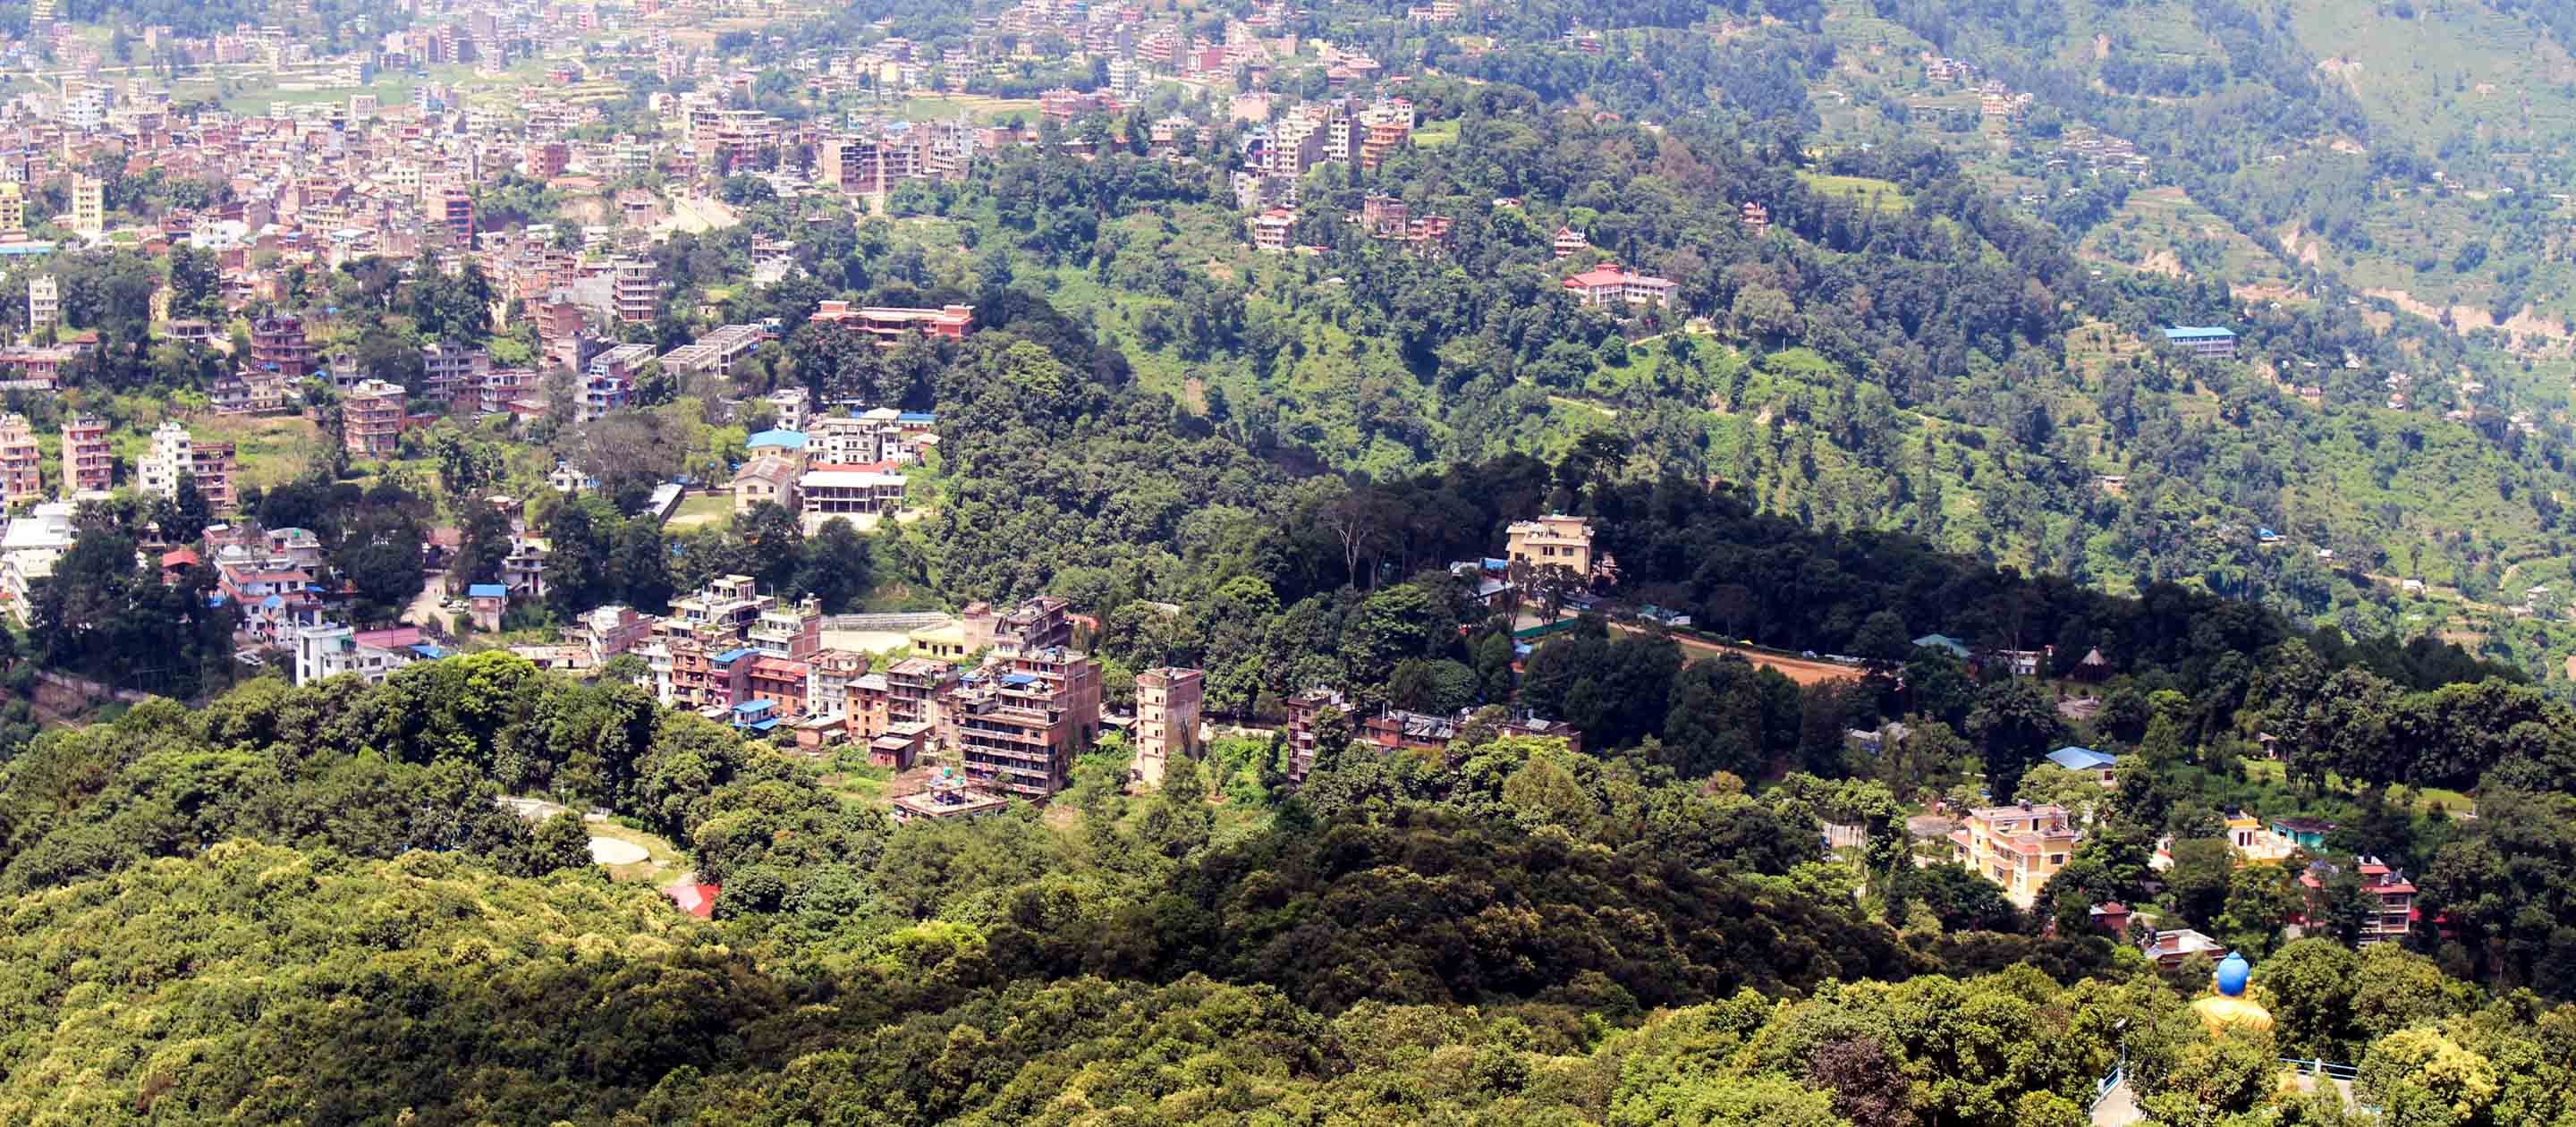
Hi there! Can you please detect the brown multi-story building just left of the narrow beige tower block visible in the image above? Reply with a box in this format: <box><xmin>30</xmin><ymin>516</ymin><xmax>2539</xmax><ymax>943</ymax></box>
<box><xmin>940</xmin><ymin>646</ymin><xmax>1100</xmax><ymax>798</ymax></box>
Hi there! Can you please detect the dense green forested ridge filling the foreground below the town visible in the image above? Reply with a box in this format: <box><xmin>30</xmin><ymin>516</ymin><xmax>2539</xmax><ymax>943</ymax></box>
<box><xmin>14</xmin><ymin>657</ymin><xmax>2576</xmax><ymax>1127</ymax></box>
